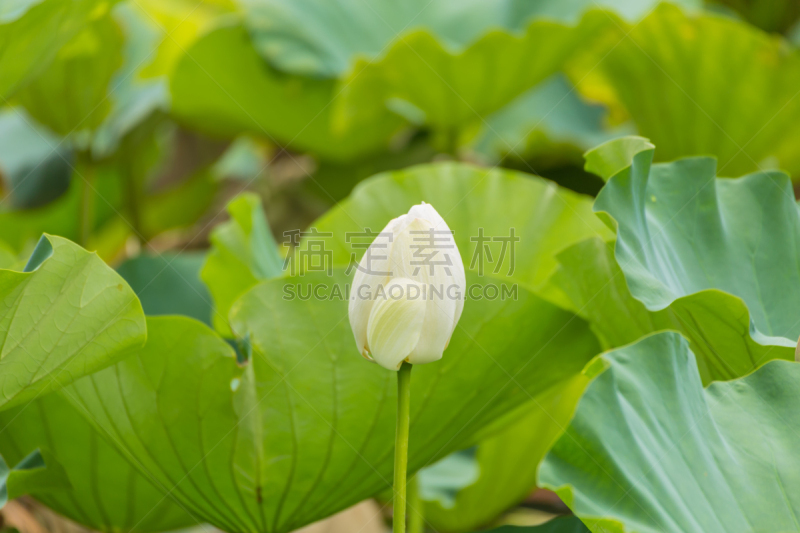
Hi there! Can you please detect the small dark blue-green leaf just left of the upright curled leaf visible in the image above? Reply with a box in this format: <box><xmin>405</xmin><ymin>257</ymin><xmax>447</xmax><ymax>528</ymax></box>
<box><xmin>117</xmin><ymin>252</ymin><xmax>211</xmax><ymax>325</ymax></box>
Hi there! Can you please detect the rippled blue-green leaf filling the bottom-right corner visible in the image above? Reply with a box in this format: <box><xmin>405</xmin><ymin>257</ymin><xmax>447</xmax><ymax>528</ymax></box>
<box><xmin>539</xmin><ymin>332</ymin><xmax>800</xmax><ymax>533</ymax></box>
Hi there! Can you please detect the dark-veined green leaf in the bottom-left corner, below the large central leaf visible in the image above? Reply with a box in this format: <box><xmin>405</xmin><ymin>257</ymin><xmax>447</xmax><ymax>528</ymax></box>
<box><xmin>0</xmin><ymin>393</ymin><xmax>197</xmax><ymax>532</ymax></box>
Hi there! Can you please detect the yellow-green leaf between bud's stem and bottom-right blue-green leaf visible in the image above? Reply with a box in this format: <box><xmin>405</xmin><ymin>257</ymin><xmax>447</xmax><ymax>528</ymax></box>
<box><xmin>418</xmin><ymin>374</ymin><xmax>587</xmax><ymax>532</ymax></box>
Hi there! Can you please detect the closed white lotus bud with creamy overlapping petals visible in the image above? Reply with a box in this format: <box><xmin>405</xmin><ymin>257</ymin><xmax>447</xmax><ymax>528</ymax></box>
<box><xmin>349</xmin><ymin>203</ymin><xmax>466</xmax><ymax>370</ymax></box>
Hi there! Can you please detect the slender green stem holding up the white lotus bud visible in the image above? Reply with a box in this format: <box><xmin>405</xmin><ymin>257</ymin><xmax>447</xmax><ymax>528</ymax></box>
<box><xmin>392</xmin><ymin>363</ymin><xmax>411</xmax><ymax>533</ymax></box>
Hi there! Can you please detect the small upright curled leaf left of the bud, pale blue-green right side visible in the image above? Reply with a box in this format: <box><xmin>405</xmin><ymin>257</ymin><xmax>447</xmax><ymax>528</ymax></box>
<box><xmin>200</xmin><ymin>193</ymin><xmax>283</xmax><ymax>336</ymax></box>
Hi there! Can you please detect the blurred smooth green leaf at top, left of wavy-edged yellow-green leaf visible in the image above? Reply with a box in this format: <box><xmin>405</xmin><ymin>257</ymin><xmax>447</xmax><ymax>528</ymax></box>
<box><xmin>170</xmin><ymin>24</ymin><xmax>402</xmax><ymax>160</ymax></box>
